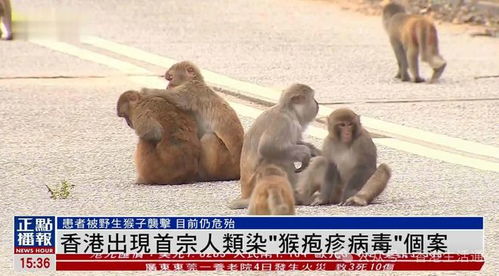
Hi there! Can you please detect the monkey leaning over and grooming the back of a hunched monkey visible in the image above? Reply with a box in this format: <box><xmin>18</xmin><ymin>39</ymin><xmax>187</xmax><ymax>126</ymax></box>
<box><xmin>142</xmin><ymin>61</ymin><xmax>244</xmax><ymax>180</ymax></box>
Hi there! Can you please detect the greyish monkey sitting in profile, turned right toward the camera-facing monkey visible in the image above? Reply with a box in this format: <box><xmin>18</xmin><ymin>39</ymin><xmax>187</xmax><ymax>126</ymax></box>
<box><xmin>229</xmin><ymin>84</ymin><xmax>319</xmax><ymax>209</ymax></box>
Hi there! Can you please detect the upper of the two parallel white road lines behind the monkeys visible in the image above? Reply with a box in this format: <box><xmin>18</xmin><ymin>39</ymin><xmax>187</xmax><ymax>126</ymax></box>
<box><xmin>81</xmin><ymin>36</ymin><xmax>499</xmax><ymax>159</ymax></box>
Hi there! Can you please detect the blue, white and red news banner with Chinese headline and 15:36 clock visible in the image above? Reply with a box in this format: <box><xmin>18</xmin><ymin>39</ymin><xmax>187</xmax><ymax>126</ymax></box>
<box><xmin>14</xmin><ymin>216</ymin><xmax>484</xmax><ymax>271</ymax></box>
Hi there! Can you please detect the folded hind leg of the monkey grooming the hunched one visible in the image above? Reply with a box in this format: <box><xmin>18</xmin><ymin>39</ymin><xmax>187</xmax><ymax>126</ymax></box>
<box><xmin>200</xmin><ymin>133</ymin><xmax>240</xmax><ymax>180</ymax></box>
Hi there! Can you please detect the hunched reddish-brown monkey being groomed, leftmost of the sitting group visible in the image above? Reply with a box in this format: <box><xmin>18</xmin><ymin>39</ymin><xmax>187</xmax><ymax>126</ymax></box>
<box><xmin>117</xmin><ymin>90</ymin><xmax>201</xmax><ymax>184</ymax></box>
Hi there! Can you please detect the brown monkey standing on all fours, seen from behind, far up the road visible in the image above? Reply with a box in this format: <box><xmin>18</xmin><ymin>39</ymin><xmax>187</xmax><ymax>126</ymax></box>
<box><xmin>383</xmin><ymin>3</ymin><xmax>447</xmax><ymax>83</ymax></box>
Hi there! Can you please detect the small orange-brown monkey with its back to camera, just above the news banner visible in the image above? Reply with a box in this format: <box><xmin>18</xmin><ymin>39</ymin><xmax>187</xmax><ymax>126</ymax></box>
<box><xmin>248</xmin><ymin>165</ymin><xmax>295</xmax><ymax>215</ymax></box>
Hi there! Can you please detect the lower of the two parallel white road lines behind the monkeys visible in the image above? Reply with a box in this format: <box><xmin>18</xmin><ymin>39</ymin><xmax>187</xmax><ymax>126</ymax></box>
<box><xmin>31</xmin><ymin>40</ymin><xmax>499</xmax><ymax>172</ymax></box>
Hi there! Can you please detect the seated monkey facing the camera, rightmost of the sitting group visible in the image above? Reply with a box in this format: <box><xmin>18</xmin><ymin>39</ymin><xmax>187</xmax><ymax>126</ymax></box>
<box><xmin>296</xmin><ymin>108</ymin><xmax>391</xmax><ymax>206</ymax></box>
